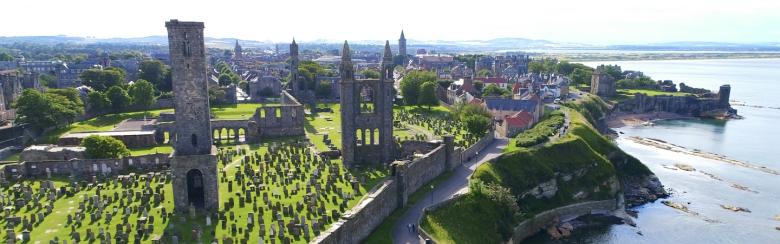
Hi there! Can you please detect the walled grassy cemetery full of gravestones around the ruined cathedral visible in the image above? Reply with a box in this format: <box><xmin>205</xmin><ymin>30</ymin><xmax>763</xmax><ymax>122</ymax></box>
<box><xmin>0</xmin><ymin>20</ymin><xmax>493</xmax><ymax>244</ymax></box>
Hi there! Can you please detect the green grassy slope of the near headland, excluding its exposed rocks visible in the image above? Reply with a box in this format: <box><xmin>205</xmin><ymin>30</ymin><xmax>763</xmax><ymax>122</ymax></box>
<box><xmin>422</xmin><ymin>98</ymin><xmax>651</xmax><ymax>243</ymax></box>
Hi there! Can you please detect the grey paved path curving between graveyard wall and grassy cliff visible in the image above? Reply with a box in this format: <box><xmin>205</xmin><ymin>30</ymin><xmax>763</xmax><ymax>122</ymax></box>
<box><xmin>393</xmin><ymin>134</ymin><xmax>509</xmax><ymax>244</ymax></box>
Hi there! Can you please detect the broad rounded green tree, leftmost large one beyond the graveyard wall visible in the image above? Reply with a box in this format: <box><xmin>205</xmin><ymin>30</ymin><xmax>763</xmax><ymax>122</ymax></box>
<box><xmin>13</xmin><ymin>89</ymin><xmax>84</xmax><ymax>129</ymax></box>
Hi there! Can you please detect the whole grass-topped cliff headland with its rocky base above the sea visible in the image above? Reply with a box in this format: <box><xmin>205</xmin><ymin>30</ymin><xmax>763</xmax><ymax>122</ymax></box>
<box><xmin>421</xmin><ymin>96</ymin><xmax>666</xmax><ymax>243</ymax></box>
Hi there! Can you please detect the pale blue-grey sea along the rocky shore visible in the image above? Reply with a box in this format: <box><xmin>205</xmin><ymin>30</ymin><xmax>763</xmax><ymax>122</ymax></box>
<box><xmin>525</xmin><ymin>59</ymin><xmax>780</xmax><ymax>244</ymax></box>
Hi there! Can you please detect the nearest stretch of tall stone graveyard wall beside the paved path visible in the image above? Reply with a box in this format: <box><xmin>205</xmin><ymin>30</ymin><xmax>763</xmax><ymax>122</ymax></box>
<box><xmin>311</xmin><ymin>179</ymin><xmax>399</xmax><ymax>244</ymax></box>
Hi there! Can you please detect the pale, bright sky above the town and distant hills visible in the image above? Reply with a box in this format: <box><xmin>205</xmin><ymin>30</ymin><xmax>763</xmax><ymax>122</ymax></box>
<box><xmin>0</xmin><ymin>0</ymin><xmax>780</xmax><ymax>45</ymax></box>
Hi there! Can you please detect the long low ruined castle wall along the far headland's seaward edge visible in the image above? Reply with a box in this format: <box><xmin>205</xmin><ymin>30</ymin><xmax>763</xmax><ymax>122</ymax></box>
<box><xmin>617</xmin><ymin>93</ymin><xmax>730</xmax><ymax>116</ymax></box>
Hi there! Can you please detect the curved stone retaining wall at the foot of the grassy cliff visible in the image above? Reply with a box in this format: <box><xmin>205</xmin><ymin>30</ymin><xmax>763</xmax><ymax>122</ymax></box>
<box><xmin>507</xmin><ymin>199</ymin><xmax>617</xmax><ymax>243</ymax></box>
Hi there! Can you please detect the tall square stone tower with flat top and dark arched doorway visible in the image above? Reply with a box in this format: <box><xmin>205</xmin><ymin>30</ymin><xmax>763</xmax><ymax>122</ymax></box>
<box><xmin>165</xmin><ymin>19</ymin><xmax>219</xmax><ymax>212</ymax></box>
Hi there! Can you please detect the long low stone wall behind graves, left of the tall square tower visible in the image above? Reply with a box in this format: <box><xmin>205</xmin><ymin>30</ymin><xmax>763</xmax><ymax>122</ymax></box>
<box><xmin>2</xmin><ymin>153</ymin><xmax>170</xmax><ymax>178</ymax></box>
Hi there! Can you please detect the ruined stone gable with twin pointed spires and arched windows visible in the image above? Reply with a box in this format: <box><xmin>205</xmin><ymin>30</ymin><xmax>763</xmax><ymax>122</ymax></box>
<box><xmin>339</xmin><ymin>41</ymin><xmax>395</xmax><ymax>166</ymax></box>
